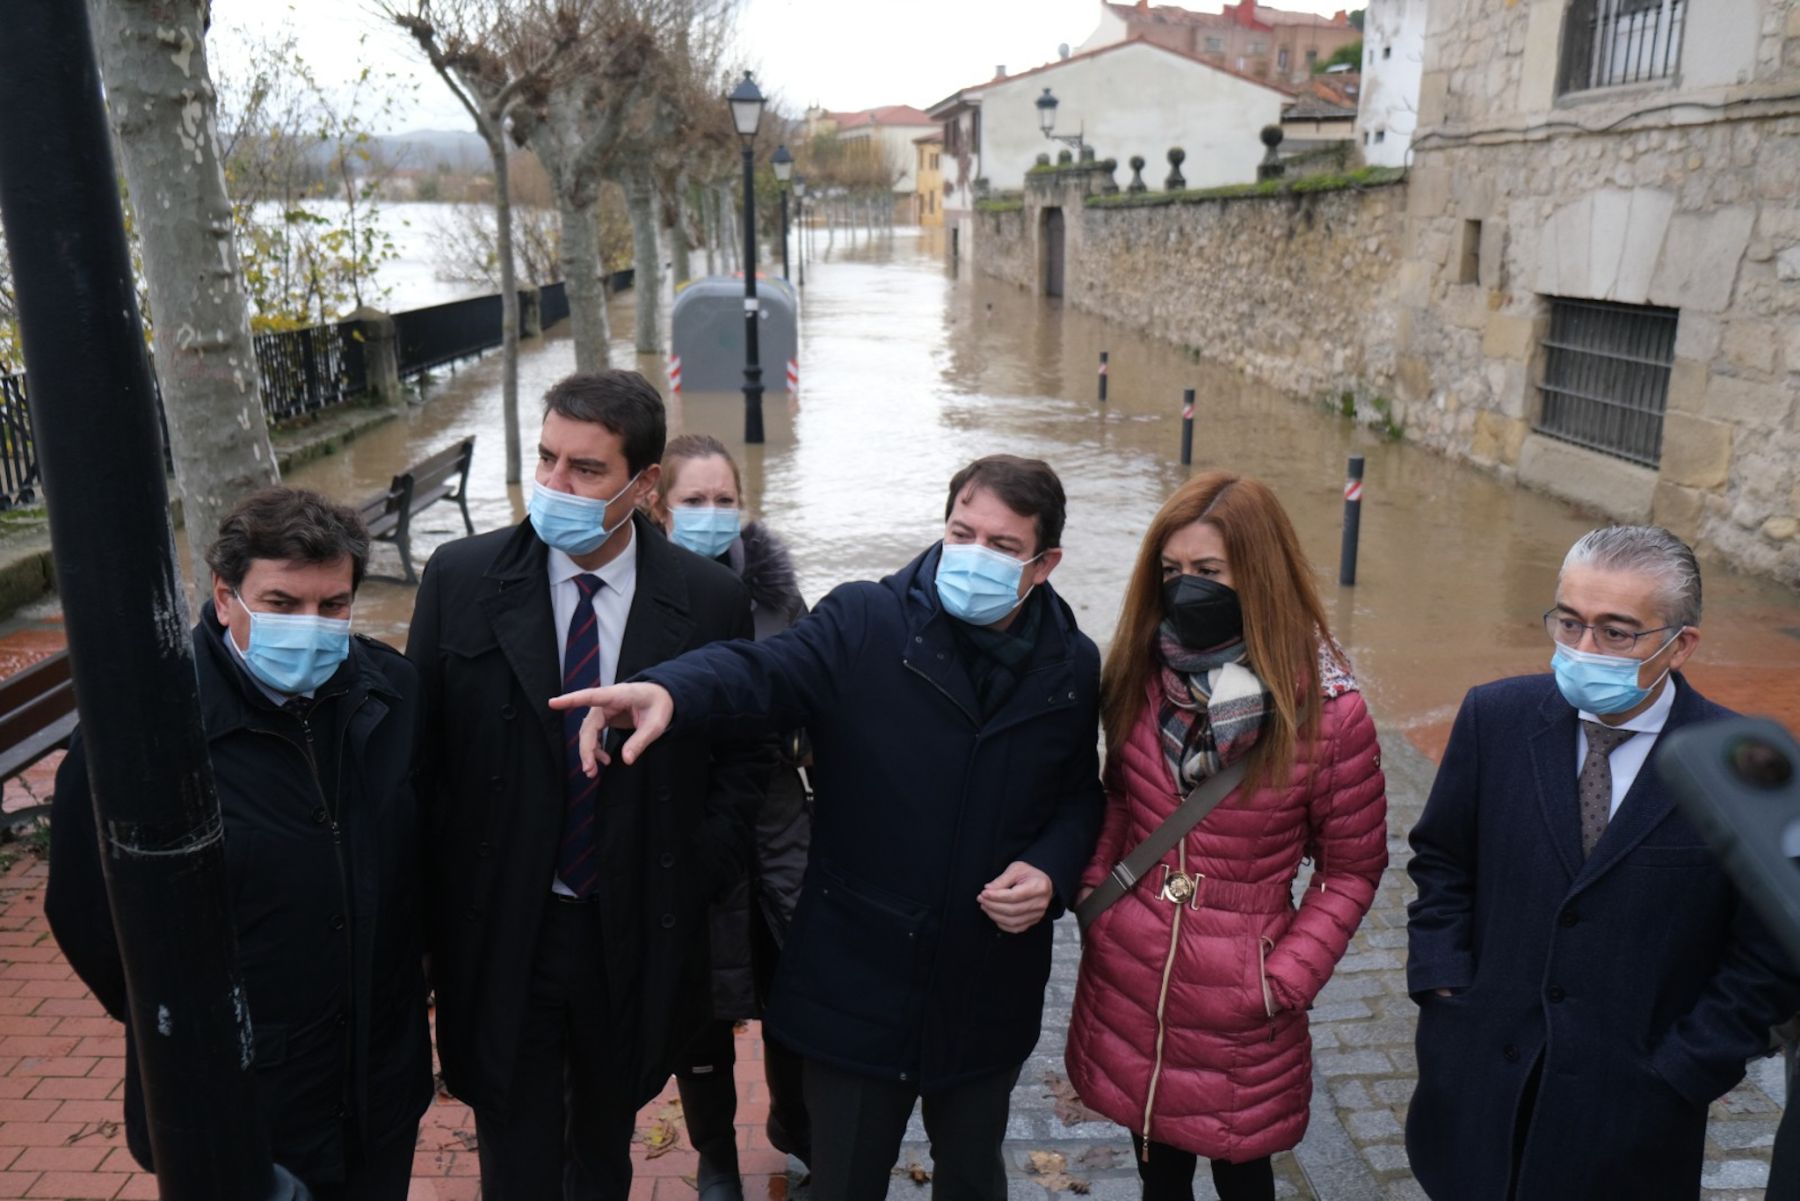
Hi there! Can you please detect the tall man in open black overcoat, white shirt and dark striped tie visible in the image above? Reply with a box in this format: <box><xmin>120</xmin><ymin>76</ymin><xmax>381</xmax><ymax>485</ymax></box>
<box><xmin>407</xmin><ymin>371</ymin><xmax>774</xmax><ymax>1201</ymax></box>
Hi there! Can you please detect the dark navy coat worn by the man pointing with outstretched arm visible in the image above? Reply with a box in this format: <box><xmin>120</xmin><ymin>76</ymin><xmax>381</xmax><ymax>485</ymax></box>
<box><xmin>644</xmin><ymin>546</ymin><xmax>1103</xmax><ymax>1091</ymax></box>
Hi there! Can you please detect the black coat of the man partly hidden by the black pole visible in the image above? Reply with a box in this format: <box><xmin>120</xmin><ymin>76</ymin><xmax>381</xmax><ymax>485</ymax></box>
<box><xmin>45</xmin><ymin>601</ymin><xmax>432</xmax><ymax>1185</ymax></box>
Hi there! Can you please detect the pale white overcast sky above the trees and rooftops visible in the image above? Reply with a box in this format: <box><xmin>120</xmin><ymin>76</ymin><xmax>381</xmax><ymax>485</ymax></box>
<box><xmin>211</xmin><ymin>0</ymin><xmax>1343</xmax><ymax>133</ymax></box>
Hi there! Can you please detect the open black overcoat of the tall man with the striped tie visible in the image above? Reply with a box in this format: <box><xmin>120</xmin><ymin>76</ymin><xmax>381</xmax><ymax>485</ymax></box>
<box><xmin>407</xmin><ymin>515</ymin><xmax>774</xmax><ymax>1113</ymax></box>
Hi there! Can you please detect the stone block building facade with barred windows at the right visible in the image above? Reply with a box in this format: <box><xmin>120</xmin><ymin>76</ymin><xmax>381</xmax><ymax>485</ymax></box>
<box><xmin>1393</xmin><ymin>0</ymin><xmax>1800</xmax><ymax>582</ymax></box>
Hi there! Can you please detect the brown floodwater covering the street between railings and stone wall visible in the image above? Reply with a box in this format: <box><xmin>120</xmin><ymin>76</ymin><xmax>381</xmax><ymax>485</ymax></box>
<box><xmin>290</xmin><ymin>230</ymin><xmax>1800</xmax><ymax>753</ymax></box>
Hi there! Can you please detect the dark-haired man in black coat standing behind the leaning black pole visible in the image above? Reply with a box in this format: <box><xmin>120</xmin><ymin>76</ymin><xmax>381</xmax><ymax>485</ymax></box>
<box><xmin>45</xmin><ymin>488</ymin><xmax>432</xmax><ymax>1201</ymax></box>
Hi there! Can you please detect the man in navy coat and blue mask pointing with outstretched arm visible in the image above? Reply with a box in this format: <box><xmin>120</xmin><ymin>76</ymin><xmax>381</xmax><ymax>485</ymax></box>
<box><xmin>558</xmin><ymin>456</ymin><xmax>1103</xmax><ymax>1201</ymax></box>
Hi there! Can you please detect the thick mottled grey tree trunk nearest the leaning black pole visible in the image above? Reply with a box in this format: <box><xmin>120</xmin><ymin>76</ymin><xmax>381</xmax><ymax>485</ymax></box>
<box><xmin>87</xmin><ymin>0</ymin><xmax>281</xmax><ymax>600</ymax></box>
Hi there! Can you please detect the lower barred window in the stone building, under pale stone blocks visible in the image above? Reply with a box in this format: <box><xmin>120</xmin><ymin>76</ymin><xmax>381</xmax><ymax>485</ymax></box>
<box><xmin>1537</xmin><ymin>299</ymin><xmax>1679</xmax><ymax>466</ymax></box>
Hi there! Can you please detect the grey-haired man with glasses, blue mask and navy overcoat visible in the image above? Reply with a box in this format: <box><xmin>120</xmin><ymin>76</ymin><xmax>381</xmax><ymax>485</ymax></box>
<box><xmin>1406</xmin><ymin>528</ymin><xmax>1800</xmax><ymax>1201</ymax></box>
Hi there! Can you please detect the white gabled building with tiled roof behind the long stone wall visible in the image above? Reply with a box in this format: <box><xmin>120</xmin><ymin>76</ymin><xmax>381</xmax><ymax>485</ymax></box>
<box><xmin>964</xmin><ymin>38</ymin><xmax>1289</xmax><ymax>191</ymax></box>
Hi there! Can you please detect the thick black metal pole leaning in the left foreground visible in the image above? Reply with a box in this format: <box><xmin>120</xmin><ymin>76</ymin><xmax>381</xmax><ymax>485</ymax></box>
<box><xmin>0</xmin><ymin>4</ymin><xmax>306</xmax><ymax>1201</ymax></box>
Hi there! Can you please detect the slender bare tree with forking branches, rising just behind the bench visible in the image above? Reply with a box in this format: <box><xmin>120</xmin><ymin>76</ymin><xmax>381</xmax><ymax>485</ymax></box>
<box><xmin>376</xmin><ymin>0</ymin><xmax>596</xmax><ymax>484</ymax></box>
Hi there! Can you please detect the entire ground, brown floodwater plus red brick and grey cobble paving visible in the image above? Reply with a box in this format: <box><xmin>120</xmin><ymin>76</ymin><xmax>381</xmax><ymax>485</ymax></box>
<box><xmin>0</xmin><ymin>230</ymin><xmax>1800</xmax><ymax>1201</ymax></box>
